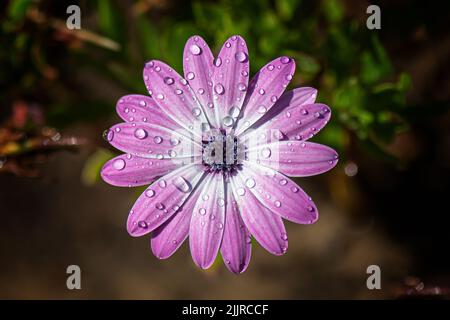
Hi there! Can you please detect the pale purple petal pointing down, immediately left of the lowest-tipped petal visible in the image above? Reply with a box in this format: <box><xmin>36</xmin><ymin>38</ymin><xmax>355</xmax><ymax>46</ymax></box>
<box><xmin>189</xmin><ymin>173</ymin><xmax>225</xmax><ymax>269</ymax></box>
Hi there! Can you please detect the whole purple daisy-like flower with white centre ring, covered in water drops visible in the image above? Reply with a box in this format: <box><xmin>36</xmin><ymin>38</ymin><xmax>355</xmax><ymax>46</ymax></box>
<box><xmin>101</xmin><ymin>36</ymin><xmax>338</xmax><ymax>273</ymax></box>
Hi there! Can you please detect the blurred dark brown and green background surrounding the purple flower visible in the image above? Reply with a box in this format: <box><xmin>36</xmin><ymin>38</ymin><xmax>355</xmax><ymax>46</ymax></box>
<box><xmin>0</xmin><ymin>0</ymin><xmax>450</xmax><ymax>299</ymax></box>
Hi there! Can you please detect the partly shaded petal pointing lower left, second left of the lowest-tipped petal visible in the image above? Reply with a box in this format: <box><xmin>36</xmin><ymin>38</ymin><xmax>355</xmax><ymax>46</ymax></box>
<box><xmin>151</xmin><ymin>182</ymin><xmax>202</xmax><ymax>259</ymax></box>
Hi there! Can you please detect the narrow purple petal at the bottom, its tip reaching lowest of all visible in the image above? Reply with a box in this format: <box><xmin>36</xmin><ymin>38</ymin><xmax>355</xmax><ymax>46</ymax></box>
<box><xmin>220</xmin><ymin>184</ymin><xmax>252</xmax><ymax>273</ymax></box>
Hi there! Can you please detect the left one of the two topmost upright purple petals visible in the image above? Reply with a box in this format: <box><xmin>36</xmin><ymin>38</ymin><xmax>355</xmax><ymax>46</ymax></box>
<box><xmin>183</xmin><ymin>36</ymin><xmax>217</xmax><ymax>128</ymax></box>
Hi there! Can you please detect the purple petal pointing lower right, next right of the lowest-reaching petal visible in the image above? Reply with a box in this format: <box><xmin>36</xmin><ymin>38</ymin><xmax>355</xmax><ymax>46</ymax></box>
<box><xmin>231</xmin><ymin>176</ymin><xmax>288</xmax><ymax>255</ymax></box>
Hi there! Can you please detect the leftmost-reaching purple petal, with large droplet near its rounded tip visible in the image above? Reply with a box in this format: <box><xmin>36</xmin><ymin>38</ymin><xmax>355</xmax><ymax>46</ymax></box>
<box><xmin>100</xmin><ymin>154</ymin><xmax>180</xmax><ymax>187</ymax></box>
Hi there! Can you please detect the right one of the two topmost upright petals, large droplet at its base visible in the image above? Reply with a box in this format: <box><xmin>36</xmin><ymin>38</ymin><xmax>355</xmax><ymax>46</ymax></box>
<box><xmin>213</xmin><ymin>36</ymin><xmax>249</xmax><ymax>129</ymax></box>
